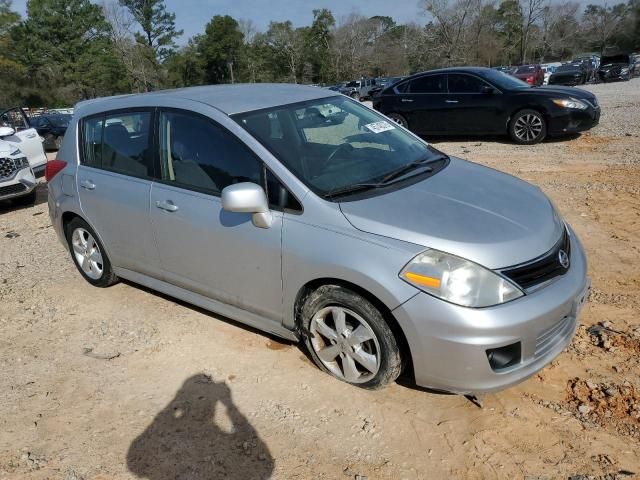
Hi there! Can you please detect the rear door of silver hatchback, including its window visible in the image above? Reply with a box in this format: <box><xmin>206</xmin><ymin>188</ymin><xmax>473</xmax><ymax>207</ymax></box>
<box><xmin>76</xmin><ymin>109</ymin><xmax>160</xmax><ymax>277</ymax></box>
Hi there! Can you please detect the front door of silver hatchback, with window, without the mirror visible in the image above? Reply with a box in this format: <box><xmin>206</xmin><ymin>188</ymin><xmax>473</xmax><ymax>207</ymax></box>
<box><xmin>150</xmin><ymin>110</ymin><xmax>282</xmax><ymax>323</ymax></box>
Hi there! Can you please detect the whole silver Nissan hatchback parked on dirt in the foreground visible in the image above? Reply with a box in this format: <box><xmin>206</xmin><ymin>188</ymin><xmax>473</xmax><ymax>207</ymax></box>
<box><xmin>46</xmin><ymin>84</ymin><xmax>589</xmax><ymax>394</ymax></box>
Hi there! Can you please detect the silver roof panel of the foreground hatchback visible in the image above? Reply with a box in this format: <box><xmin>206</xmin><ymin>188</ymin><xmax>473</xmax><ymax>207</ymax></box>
<box><xmin>76</xmin><ymin>83</ymin><xmax>339</xmax><ymax>115</ymax></box>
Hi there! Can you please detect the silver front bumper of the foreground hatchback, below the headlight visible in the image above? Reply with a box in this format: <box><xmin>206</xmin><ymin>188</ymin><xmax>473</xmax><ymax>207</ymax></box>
<box><xmin>393</xmin><ymin>231</ymin><xmax>590</xmax><ymax>394</ymax></box>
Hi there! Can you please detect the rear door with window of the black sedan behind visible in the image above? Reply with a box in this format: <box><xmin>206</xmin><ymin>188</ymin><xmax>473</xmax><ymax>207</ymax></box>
<box><xmin>396</xmin><ymin>74</ymin><xmax>449</xmax><ymax>134</ymax></box>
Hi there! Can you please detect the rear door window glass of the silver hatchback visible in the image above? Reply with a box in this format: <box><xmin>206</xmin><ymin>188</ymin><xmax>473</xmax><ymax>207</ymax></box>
<box><xmin>83</xmin><ymin>112</ymin><xmax>153</xmax><ymax>178</ymax></box>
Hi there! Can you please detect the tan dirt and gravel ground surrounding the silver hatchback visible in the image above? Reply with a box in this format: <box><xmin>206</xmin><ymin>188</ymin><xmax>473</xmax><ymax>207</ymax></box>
<box><xmin>0</xmin><ymin>79</ymin><xmax>640</xmax><ymax>480</ymax></box>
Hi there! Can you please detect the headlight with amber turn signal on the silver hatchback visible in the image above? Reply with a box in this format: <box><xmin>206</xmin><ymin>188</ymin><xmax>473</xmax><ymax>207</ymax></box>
<box><xmin>400</xmin><ymin>250</ymin><xmax>524</xmax><ymax>307</ymax></box>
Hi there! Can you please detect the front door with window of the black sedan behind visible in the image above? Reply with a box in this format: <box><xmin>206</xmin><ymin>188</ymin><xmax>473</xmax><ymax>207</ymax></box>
<box><xmin>445</xmin><ymin>73</ymin><xmax>506</xmax><ymax>135</ymax></box>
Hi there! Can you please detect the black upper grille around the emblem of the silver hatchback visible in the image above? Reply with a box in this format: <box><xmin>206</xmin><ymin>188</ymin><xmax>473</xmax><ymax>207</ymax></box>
<box><xmin>502</xmin><ymin>229</ymin><xmax>571</xmax><ymax>290</ymax></box>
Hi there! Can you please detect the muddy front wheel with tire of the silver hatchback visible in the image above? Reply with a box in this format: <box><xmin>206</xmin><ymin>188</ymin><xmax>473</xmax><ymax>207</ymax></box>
<box><xmin>301</xmin><ymin>285</ymin><xmax>402</xmax><ymax>390</ymax></box>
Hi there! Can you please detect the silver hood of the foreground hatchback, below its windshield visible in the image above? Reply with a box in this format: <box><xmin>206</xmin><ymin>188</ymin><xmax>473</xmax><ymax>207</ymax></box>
<box><xmin>340</xmin><ymin>158</ymin><xmax>563</xmax><ymax>268</ymax></box>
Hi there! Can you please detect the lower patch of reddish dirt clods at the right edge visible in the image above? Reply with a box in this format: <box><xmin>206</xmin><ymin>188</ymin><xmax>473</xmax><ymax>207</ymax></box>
<box><xmin>566</xmin><ymin>378</ymin><xmax>640</xmax><ymax>440</ymax></box>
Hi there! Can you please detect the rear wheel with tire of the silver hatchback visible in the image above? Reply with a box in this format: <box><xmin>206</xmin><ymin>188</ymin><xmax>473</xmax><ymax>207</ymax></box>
<box><xmin>65</xmin><ymin>217</ymin><xmax>118</xmax><ymax>288</ymax></box>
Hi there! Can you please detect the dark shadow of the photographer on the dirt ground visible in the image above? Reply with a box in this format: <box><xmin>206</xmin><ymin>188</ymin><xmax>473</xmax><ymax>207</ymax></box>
<box><xmin>127</xmin><ymin>374</ymin><xmax>274</xmax><ymax>480</ymax></box>
